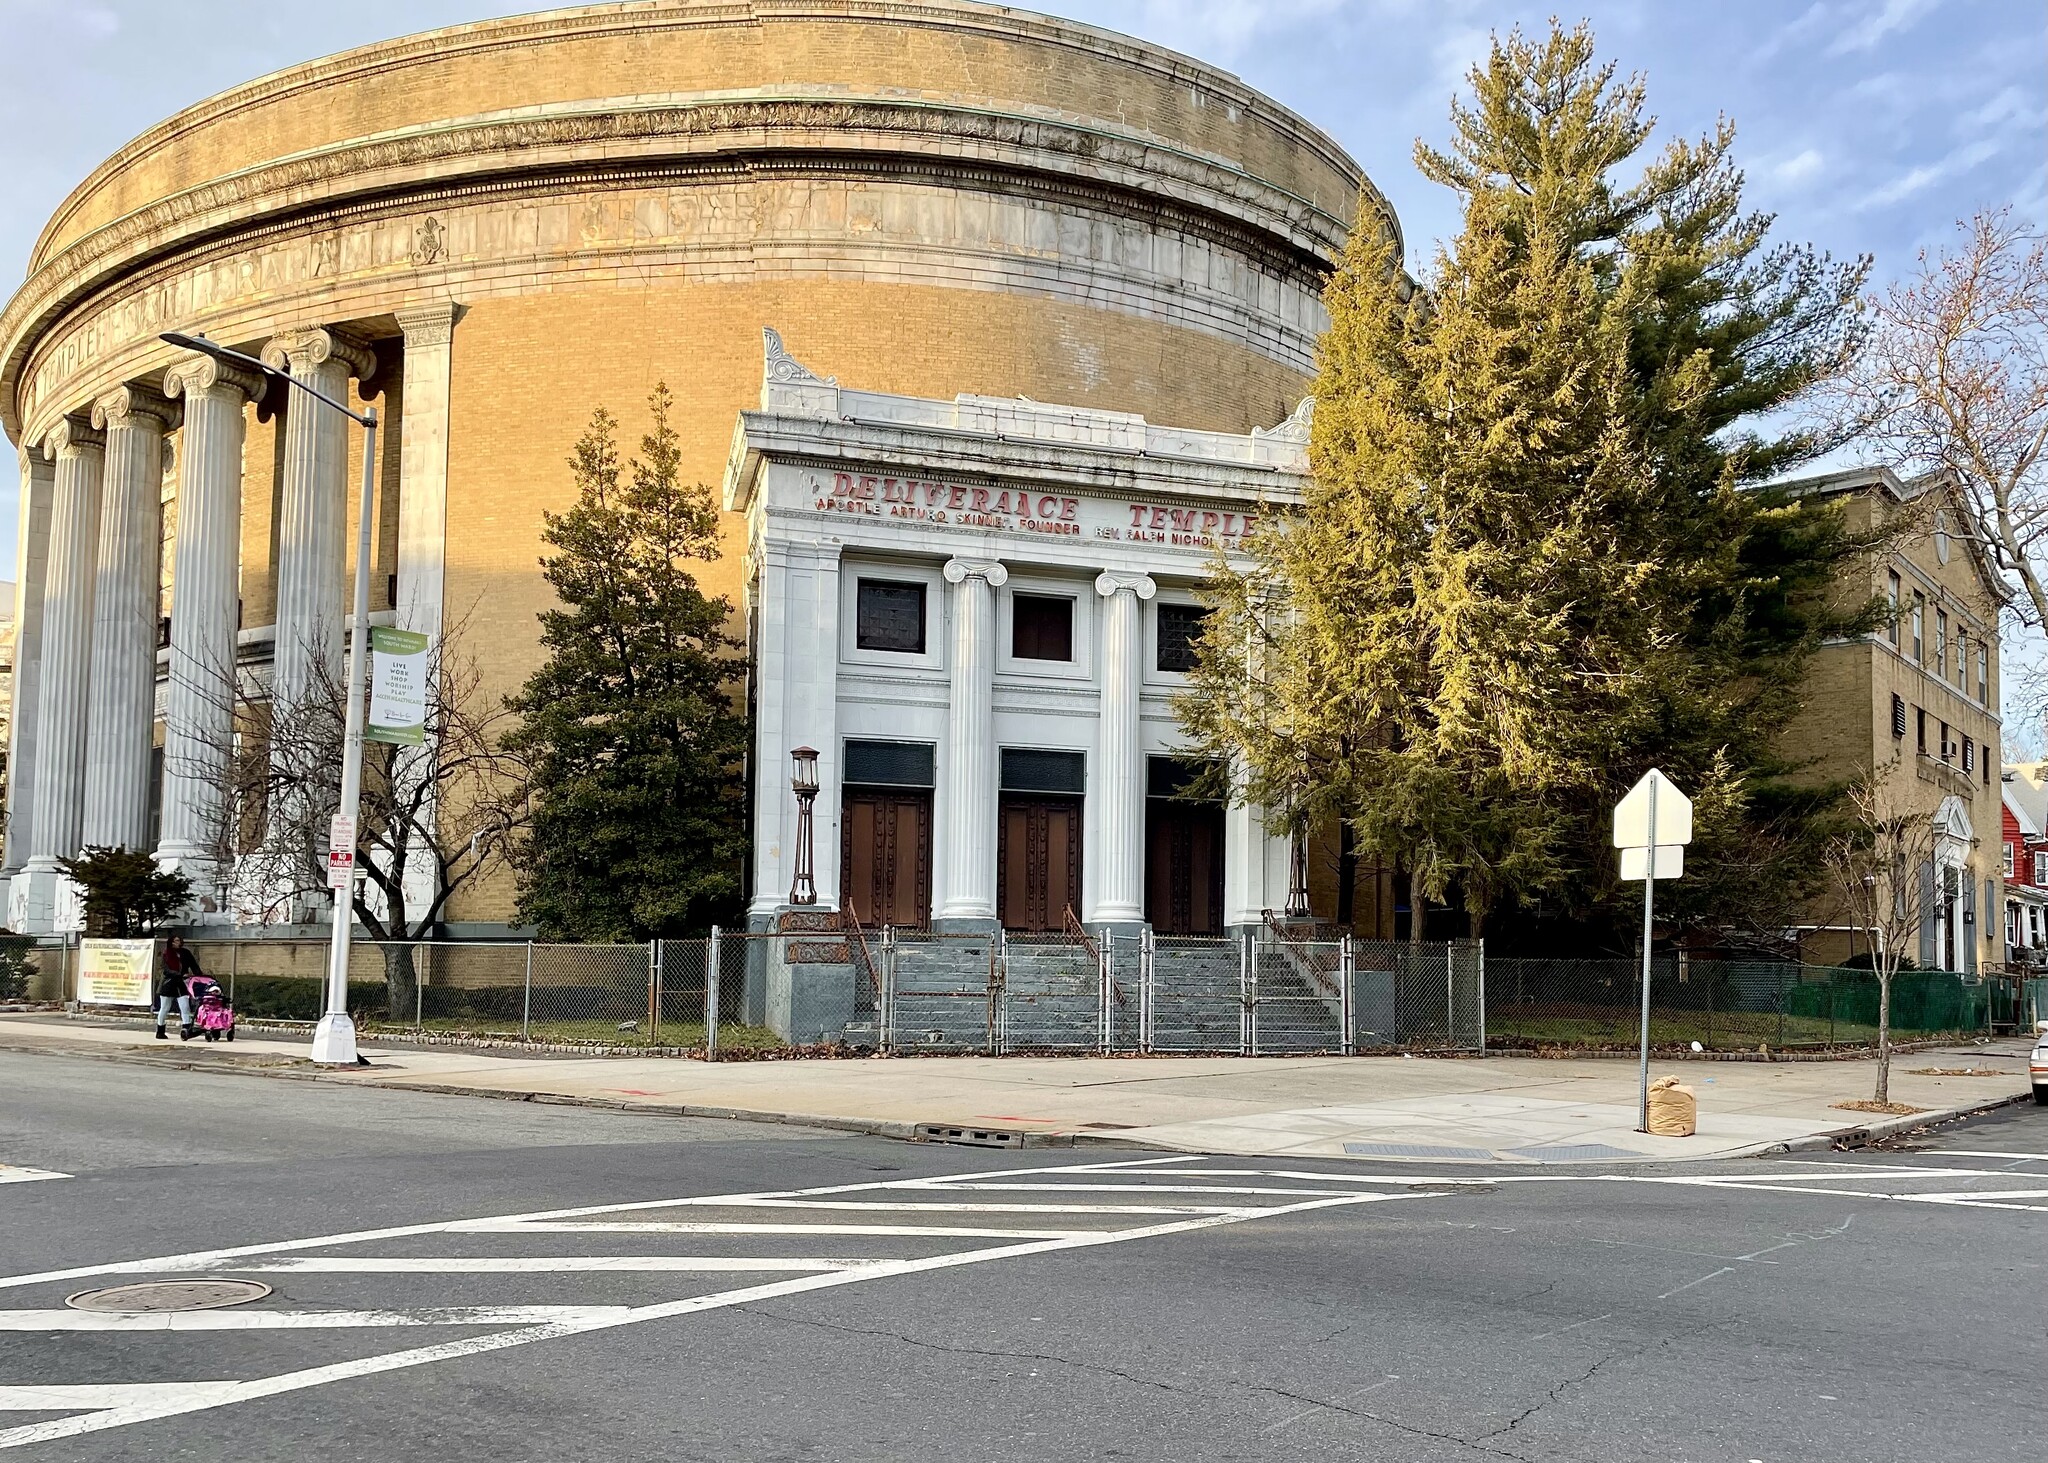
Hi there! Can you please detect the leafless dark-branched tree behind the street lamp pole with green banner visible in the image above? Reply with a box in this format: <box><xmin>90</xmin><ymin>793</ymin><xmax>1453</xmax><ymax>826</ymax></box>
<box><xmin>188</xmin><ymin>625</ymin><xmax>528</xmax><ymax>1014</ymax></box>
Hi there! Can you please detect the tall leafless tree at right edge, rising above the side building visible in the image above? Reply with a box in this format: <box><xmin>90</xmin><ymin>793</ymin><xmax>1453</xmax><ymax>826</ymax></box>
<box><xmin>1849</xmin><ymin>209</ymin><xmax>2048</xmax><ymax>627</ymax></box>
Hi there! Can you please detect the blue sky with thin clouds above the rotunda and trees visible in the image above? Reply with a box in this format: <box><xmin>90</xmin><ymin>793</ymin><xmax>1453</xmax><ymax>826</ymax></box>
<box><xmin>0</xmin><ymin>0</ymin><xmax>2048</xmax><ymax>574</ymax></box>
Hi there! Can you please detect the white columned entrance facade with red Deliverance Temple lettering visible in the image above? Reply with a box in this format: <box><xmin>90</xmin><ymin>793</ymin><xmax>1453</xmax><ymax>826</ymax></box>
<box><xmin>725</xmin><ymin>330</ymin><xmax>1307</xmax><ymax>926</ymax></box>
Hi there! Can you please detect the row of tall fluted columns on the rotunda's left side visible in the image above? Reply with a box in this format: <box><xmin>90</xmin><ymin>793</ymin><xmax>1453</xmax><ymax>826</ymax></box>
<box><xmin>0</xmin><ymin>315</ymin><xmax>459</xmax><ymax>932</ymax></box>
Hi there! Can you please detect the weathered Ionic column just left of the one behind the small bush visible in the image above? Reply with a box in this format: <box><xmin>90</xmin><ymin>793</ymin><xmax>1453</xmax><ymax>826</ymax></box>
<box><xmin>27</xmin><ymin>416</ymin><xmax>106</xmax><ymax>901</ymax></box>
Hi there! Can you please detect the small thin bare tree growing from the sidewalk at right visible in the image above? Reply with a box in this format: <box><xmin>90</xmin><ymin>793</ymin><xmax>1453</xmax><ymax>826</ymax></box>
<box><xmin>1827</xmin><ymin>756</ymin><xmax>1942</xmax><ymax>1102</ymax></box>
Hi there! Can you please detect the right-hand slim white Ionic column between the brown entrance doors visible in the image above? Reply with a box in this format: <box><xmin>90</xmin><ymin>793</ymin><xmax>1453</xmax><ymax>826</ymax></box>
<box><xmin>1090</xmin><ymin>572</ymin><xmax>1157</xmax><ymax>924</ymax></box>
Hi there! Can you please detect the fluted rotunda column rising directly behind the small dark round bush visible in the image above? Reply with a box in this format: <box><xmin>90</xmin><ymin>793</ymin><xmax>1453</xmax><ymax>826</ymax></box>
<box><xmin>82</xmin><ymin>385</ymin><xmax>176</xmax><ymax>852</ymax></box>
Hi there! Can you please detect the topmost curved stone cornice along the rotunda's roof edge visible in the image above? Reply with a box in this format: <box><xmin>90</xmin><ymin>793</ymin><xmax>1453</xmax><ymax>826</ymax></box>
<box><xmin>31</xmin><ymin>0</ymin><xmax>1393</xmax><ymax>273</ymax></box>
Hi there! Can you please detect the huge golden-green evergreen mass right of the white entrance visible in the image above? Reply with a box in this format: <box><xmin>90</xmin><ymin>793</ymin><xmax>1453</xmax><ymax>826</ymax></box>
<box><xmin>1186</xmin><ymin>25</ymin><xmax>1870</xmax><ymax>946</ymax></box>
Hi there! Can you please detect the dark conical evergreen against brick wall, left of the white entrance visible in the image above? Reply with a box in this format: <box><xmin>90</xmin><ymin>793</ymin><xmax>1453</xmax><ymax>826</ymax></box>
<box><xmin>508</xmin><ymin>385</ymin><xmax>748</xmax><ymax>941</ymax></box>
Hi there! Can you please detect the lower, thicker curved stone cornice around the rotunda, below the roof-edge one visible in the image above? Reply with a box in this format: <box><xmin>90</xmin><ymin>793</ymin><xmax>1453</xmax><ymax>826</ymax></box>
<box><xmin>0</xmin><ymin>94</ymin><xmax>1368</xmax><ymax>432</ymax></box>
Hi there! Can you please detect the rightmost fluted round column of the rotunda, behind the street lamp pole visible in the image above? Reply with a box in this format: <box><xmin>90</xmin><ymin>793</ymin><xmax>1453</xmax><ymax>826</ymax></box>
<box><xmin>262</xmin><ymin>330</ymin><xmax>377</xmax><ymax>717</ymax></box>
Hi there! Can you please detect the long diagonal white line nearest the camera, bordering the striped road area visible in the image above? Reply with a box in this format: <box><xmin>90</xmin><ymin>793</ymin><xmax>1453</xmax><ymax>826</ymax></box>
<box><xmin>0</xmin><ymin>1184</ymin><xmax>1421</xmax><ymax>1449</ymax></box>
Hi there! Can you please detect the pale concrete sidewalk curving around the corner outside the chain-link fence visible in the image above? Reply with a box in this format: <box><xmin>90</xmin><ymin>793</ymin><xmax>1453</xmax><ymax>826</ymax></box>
<box><xmin>0</xmin><ymin>1016</ymin><xmax>2030</xmax><ymax>1164</ymax></box>
